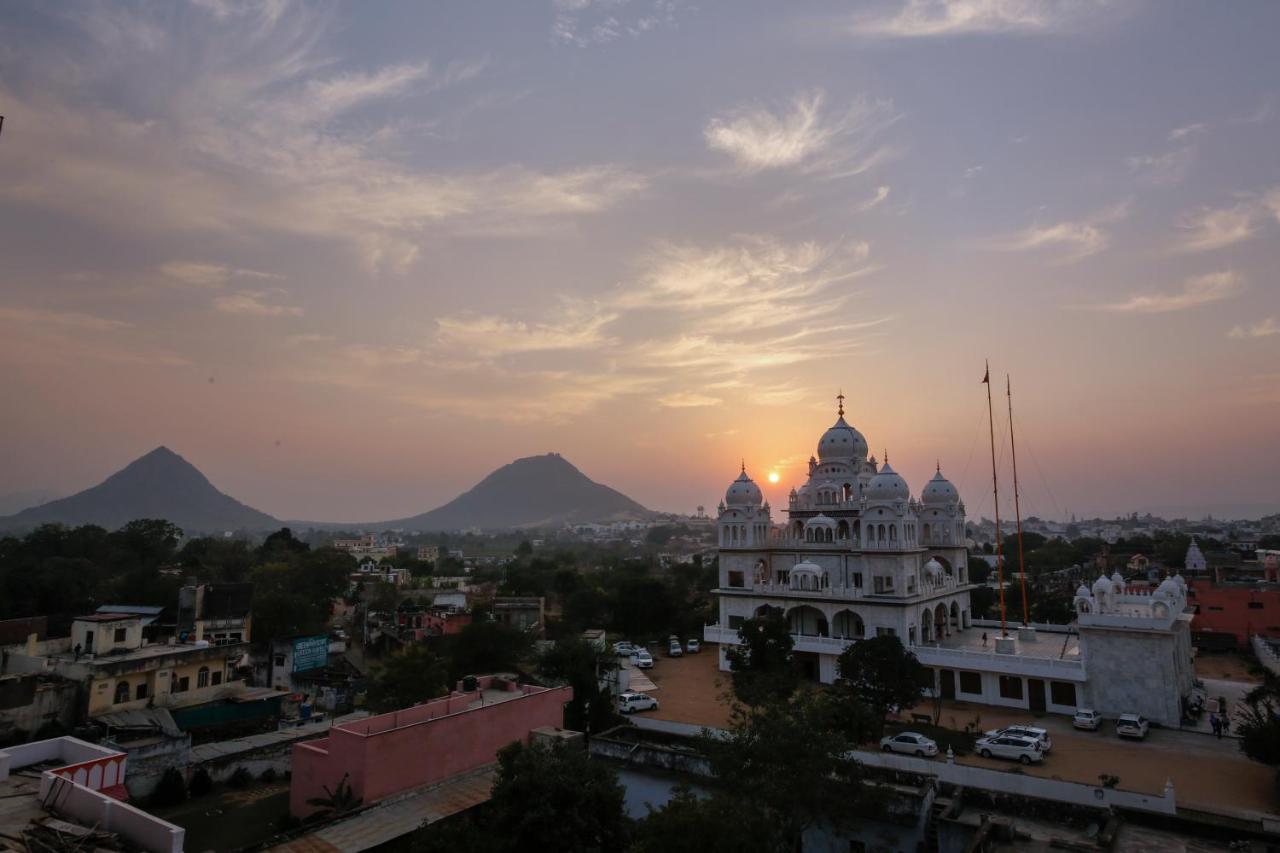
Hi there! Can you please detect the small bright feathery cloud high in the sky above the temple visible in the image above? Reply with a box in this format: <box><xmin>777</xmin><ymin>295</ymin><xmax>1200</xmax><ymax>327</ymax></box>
<box><xmin>703</xmin><ymin>91</ymin><xmax>897</xmax><ymax>177</ymax></box>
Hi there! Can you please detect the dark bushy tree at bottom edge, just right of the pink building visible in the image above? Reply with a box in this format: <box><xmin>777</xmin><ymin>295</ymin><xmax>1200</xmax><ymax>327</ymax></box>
<box><xmin>489</xmin><ymin>742</ymin><xmax>630</xmax><ymax>853</ymax></box>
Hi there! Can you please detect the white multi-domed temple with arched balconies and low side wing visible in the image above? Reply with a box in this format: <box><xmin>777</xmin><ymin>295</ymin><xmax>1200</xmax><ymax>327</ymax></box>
<box><xmin>704</xmin><ymin>397</ymin><xmax>1194</xmax><ymax>725</ymax></box>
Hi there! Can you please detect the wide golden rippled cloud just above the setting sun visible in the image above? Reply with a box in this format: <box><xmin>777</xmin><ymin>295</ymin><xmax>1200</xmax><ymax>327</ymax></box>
<box><xmin>286</xmin><ymin>237</ymin><xmax>891</xmax><ymax>421</ymax></box>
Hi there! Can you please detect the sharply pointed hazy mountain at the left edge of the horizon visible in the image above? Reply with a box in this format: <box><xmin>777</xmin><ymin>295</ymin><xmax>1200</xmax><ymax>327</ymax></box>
<box><xmin>0</xmin><ymin>447</ymin><xmax>280</xmax><ymax>534</ymax></box>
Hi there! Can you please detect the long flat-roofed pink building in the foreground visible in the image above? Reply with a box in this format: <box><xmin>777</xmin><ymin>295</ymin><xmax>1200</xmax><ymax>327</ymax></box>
<box><xmin>289</xmin><ymin>676</ymin><xmax>573</xmax><ymax>817</ymax></box>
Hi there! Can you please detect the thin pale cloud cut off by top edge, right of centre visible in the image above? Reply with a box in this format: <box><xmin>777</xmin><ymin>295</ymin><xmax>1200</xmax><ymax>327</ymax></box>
<box><xmin>846</xmin><ymin>0</ymin><xmax>1121</xmax><ymax>38</ymax></box>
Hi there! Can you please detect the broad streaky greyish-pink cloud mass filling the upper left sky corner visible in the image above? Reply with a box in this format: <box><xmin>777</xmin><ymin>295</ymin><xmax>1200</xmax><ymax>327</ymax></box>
<box><xmin>0</xmin><ymin>0</ymin><xmax>646</xmax><ymax>268</ymax></box>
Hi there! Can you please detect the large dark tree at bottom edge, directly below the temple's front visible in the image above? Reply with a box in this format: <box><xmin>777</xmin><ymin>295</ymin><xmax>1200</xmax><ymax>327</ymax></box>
<box><xmin>701</xmin><ymin>690</ymin><xmax>872</xmax><ymax>852</ymax></box>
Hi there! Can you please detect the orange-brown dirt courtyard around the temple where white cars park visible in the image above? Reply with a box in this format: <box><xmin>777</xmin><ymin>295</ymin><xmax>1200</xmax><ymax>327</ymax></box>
<box><xmin>644</xmin><ymin>644</ymin><xmax>1280</xmax><ymax>813</ymax></box>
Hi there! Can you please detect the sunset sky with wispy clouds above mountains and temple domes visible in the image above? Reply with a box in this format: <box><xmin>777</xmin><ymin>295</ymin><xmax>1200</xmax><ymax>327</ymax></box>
<box><xmin>0</xmin><ymin>0</ymin><xmax>1280</xmax><ymax>520</ymax></box>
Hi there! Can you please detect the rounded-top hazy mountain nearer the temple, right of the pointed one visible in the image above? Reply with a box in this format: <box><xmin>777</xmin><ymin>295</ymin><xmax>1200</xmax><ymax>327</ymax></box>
<box><xmin>371</xmin><ymin>453</ymin><xmax>653</xmax><ymax>530</ymax></box>
